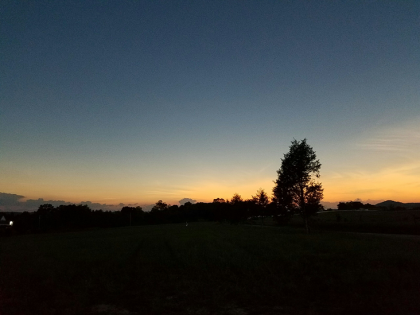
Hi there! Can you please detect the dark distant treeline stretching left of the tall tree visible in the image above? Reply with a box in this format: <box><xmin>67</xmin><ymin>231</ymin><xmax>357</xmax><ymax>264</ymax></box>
<box><xmin>0</xmin><ymin>195</ymin><xmax>277</xmax><ymax>233</ymax></box>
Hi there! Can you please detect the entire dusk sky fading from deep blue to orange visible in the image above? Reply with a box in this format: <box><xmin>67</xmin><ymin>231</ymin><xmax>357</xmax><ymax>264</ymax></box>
<box><xmin>0</xmin><ymin>0</ymin><xmax>420</xmax><ymax>209</ymax></box>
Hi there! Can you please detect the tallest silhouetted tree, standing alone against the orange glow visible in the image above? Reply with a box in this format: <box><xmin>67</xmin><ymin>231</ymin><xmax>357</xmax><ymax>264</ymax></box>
<box><xmin>273</xmin><ymin>139</ymin><xmax>323</xmax><ymax>233</ymax></box>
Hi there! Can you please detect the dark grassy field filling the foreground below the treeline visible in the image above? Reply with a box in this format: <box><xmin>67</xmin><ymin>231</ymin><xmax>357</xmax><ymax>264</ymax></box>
<box><xmin>0</xmin><ymin>223</ymin><xmax>420</xmax><ymax>315</ymax></box>
